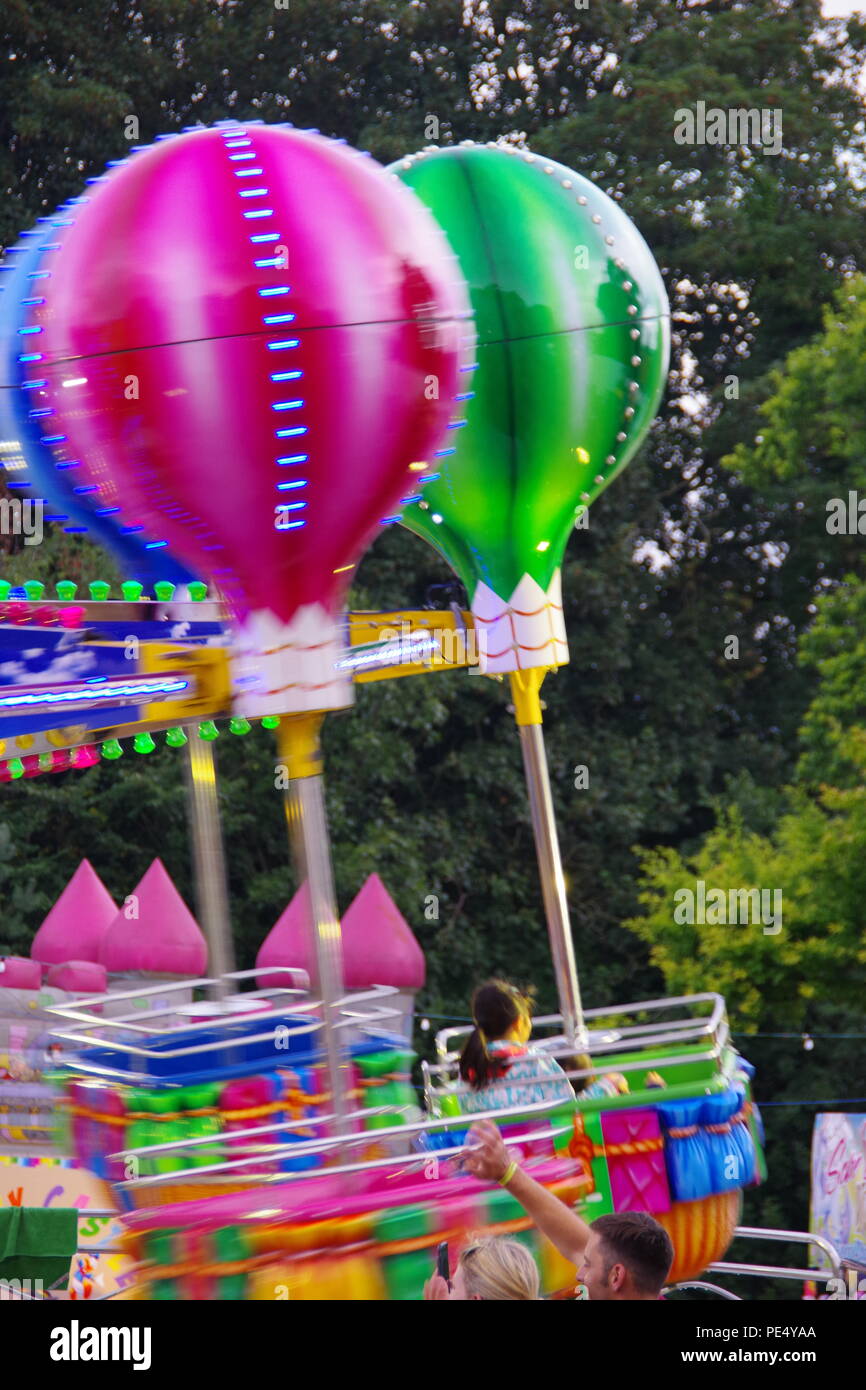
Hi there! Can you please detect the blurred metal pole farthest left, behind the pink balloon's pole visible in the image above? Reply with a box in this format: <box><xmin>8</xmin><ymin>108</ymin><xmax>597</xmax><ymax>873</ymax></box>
<box><xmin>185</xmin><ymin>731</ymin><xmax>235</xmax><ymax>998</ymax></box>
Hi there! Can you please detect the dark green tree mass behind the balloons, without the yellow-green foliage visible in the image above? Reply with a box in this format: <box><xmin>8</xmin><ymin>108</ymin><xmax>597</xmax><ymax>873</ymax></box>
<box><xmin>0</xmin><ymin>0</ymin><xmax>865</xmax><ymax>1012</ymax></box>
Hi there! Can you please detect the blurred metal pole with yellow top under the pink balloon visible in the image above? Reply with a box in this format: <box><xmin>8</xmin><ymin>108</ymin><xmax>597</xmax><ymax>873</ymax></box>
<box><xmin>277</xmin><ymin>714</ymin><xmax>349</xmax><ymax>1134</ymax></box>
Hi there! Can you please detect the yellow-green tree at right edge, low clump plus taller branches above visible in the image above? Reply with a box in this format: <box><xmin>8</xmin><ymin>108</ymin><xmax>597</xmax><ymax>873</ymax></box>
<box><xmin>628</xmin><ymin>567</ymin><xmax>866</xmax><ymax>1027</ymax></box>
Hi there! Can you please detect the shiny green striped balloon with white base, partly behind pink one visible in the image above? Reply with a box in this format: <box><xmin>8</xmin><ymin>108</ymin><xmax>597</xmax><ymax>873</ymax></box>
<box><xmin>391</xmin><ymin>143</ymin><xmax>670</xmax><ymax>673</ymax></box>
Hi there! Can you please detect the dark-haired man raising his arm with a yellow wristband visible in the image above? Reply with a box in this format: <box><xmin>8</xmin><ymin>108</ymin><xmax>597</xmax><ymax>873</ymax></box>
<box><xmin>466</xmin><ymin>1120</ymin><xmax>674</xmax><ymax>1302</ymax></box>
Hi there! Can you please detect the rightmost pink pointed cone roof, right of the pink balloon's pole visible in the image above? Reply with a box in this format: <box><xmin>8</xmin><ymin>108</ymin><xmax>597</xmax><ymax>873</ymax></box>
<box><xmin>343</xmin><ymin>873</ymin><xmax>427</xmax><ymax>990</ymax></box>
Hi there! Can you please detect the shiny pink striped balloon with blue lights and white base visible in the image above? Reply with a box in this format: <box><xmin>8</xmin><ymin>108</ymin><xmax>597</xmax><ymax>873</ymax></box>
<box><xmin>32</xmin><ymin>124</ymin><xmax>473</xmax><ymax>714</ymax></box>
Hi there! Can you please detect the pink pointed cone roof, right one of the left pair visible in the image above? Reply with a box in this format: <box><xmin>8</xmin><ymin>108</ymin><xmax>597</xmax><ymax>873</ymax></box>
<box><xmin>99</xmin><ymin>859</ymin><xmax>207</xmax><ymax>974</ymax></box>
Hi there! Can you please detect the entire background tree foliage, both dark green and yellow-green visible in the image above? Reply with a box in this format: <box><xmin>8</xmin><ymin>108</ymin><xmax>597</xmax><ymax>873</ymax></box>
<box><xmin>0</xmin><ymin>0</ymin><xmax>866</xmax><ymax>1245</ymax></box>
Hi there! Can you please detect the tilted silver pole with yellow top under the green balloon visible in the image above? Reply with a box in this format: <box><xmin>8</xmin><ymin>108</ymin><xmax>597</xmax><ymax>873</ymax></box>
<box><xmin>512</xmin><ymin>669</ymin><xmax>585</xmax><ymax>1043</ymax></box>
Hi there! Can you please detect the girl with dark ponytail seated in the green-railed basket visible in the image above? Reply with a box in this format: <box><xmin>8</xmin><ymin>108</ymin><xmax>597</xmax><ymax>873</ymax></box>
<box><xmin>460</xmin><ymin>980</ymin><xmax>574</xmax><ymax>1113</ymax></box>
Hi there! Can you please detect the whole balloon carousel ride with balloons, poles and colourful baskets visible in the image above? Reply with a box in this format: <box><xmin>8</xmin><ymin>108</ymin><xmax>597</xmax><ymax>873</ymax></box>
<box><xmin>0</xmin><ymin>122</ymin><xmax>760</xmax><ymax>1300</ymax></box>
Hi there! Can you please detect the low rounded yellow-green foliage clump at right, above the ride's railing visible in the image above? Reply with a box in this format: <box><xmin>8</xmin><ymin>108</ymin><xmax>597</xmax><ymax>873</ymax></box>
<box><xmin>631</xmin><ymin>772</ymin><xmax>866</xmax><ymax>1027</ymax></box>
